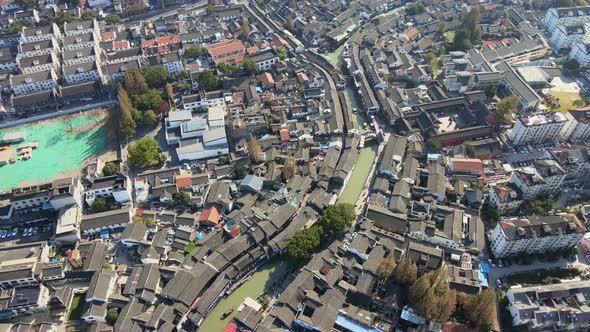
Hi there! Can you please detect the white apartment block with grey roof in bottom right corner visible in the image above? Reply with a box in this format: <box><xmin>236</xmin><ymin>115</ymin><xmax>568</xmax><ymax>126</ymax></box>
<box><xmin>506</xmin><ymin>280</ymin><xmax>590</xmax><ymax>331</ymax></box>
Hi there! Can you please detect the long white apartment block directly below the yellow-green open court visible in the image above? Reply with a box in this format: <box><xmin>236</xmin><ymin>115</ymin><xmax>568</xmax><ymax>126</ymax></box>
<box><xmin>510</xmin><ymin>112</ymin><xmax>567</xmax><ymax>145</ymax></box>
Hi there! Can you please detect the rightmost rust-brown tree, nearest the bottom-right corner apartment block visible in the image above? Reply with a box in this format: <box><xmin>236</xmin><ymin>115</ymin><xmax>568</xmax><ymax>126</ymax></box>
<box><xmin>461</xmin><ymin>289</ymin><xmax>496</xmax><ymax>331</ymax></box>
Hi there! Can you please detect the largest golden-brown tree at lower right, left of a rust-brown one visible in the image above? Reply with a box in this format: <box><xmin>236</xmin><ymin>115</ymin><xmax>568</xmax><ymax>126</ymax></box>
<box><xmin>408</xmin><ymin>268</ymin><xmax>457</xmax><ymax>323</ymax></box>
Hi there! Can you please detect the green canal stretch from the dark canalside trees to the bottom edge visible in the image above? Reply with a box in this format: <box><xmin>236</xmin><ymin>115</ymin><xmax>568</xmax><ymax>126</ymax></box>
<box><xmin>199</xmin><ymin>257</ymin><xmax>291</xmax><ymax>332</ymax></box>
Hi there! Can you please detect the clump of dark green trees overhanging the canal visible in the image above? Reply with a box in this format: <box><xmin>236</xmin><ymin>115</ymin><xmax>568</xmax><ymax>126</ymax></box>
<box><xmin>287</xmin><ymin>203</ymin><xmax>356</xmax><ymax>264</ymax></box>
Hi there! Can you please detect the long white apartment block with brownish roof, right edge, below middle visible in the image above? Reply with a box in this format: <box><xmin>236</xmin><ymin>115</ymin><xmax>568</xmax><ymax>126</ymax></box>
<box><xmin>490</xmin><ymin>213</ymin><xmax>586</xmax><ymax>258</ymax></box>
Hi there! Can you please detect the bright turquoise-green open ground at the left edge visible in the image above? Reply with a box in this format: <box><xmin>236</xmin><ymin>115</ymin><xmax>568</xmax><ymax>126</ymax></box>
<box><xmin>0</xmin><ymin>114</ymin><xmax>105</xmax><ymax>190</ymax></box>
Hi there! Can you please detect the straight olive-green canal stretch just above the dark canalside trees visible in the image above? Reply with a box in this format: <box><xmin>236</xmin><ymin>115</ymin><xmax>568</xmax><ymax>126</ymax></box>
<box><xmin>338</xmin><ymin>146</ymin><xmax>377</xmax><ymax>204</ymax></box>
